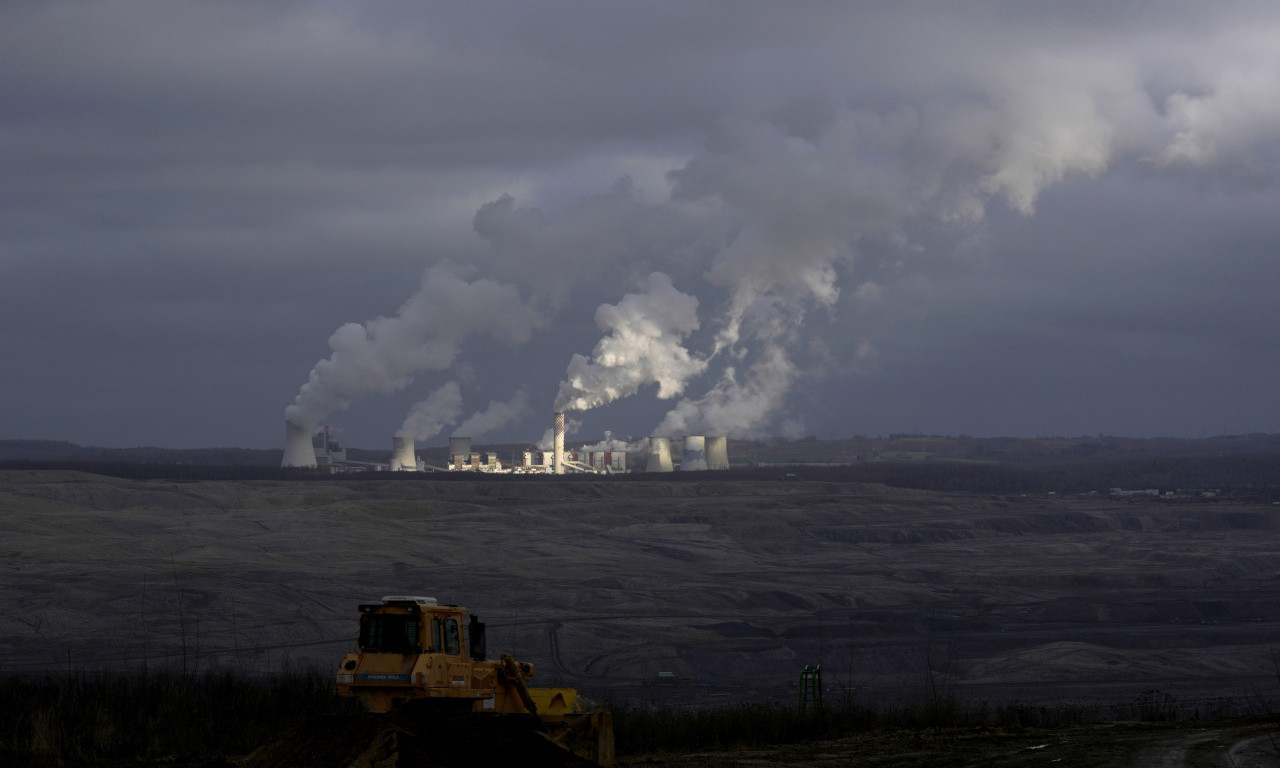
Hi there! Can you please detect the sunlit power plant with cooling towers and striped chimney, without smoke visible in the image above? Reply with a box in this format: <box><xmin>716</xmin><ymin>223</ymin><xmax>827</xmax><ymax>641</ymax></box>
<box><xmin>280</xmin><ymin>412</ymin><xmax>730</xmax><ymax>475</ymax></box>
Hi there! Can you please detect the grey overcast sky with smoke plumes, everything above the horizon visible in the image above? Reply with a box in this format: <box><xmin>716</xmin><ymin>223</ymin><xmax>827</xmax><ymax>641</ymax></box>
<box><xmin>0</xmin><ymin>0</ymin><xmax>1280</xmax><ymax>448</ymax></box>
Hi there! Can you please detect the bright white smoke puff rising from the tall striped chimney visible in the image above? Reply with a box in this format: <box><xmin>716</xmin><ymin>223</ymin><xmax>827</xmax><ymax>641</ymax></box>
<box><xmin>556</xmin><ymin>273</ymin><xmax>707</xmax><ymax>411</ymax></box>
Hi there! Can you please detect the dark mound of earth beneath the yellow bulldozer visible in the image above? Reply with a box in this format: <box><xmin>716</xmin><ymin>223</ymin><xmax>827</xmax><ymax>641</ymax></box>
<box><xmin>237</xmin><ymin>705</ymin><xmax>598</xmax><ymax>768</ymax></box>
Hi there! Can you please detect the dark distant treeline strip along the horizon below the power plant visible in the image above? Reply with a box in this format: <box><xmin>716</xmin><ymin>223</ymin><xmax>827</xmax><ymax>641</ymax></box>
<box><xmin>0</xmin><ymin>453</ymin><xmax>1280</xmax><ymax>499</ymax></box>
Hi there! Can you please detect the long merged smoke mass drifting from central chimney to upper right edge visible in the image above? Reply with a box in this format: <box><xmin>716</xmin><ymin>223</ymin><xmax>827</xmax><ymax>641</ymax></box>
<box><xmin>476</xmin><ymin>36</ymin><xmax>1280</xmax><ymax>436</ymax></box>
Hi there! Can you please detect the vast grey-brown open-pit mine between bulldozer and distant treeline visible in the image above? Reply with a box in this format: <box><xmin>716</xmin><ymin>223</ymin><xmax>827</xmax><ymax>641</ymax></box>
<box><xmin>0</xmin><ymin>471</ymin><xmax>1280</xmax><ymax>700</ymax></box>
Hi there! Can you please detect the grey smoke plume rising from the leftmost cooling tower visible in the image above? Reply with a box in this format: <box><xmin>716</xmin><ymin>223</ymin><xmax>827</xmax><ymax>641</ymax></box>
<box><xmin>284</xmin><ymin>262</ymin><xmax>540</xmax><ymax>429</ymax></box>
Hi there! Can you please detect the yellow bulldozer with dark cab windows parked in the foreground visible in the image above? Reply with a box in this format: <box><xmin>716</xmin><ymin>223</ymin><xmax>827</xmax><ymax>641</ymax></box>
<box><xmin>334</xmin><ymin>595</ymin><xmax>614</xmax><ymax>768</ymax></box>
